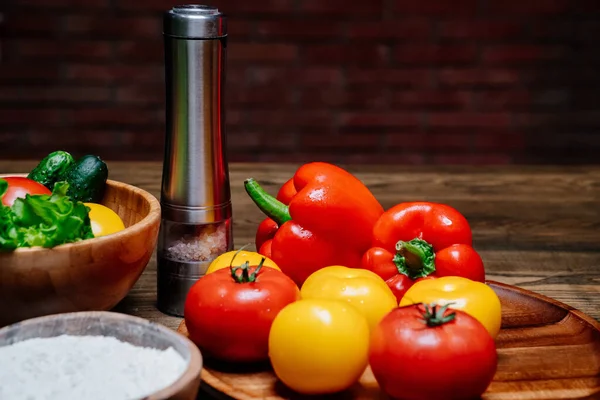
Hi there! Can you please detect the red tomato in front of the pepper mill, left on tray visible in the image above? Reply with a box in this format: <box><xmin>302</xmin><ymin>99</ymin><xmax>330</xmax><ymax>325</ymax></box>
<box><xmin>184</xmin><ymin>260</ymin><xmax>300</xmax><ymax>362</ymax></box>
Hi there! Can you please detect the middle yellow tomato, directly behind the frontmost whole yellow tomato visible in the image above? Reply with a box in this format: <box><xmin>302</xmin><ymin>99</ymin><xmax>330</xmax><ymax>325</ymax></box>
<box><xmin>300</xmin><ymin>265</ymin><xmax>398</xmax><ymax>329</ymax></box>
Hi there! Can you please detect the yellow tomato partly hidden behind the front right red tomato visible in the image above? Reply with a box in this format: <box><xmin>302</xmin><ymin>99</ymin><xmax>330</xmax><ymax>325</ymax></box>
<box><xmin>400</xmin><ymin>276</ymin><xmax>502</xmax><ymax>338</ymax></box>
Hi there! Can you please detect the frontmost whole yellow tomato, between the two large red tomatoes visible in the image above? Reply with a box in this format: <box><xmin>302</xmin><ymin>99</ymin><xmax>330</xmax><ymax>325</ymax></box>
<box><xmin>269</xmin><ymin>299</ymin><xmax>369</xmax><ymax>394</ymax></box>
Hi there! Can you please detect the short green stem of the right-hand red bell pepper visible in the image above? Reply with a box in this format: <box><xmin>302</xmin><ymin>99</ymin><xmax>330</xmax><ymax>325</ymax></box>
<box><xmin>393</xmin><ymin>238</ymin><xmax>435</xmax><ymax>279</ymax></box>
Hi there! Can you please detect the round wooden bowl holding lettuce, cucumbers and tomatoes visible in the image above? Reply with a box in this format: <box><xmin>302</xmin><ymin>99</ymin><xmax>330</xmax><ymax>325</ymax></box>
<box><xmin>0</xmin><ymin>178</ymin><xmax>160</xmax><ymax>327</ymax></box>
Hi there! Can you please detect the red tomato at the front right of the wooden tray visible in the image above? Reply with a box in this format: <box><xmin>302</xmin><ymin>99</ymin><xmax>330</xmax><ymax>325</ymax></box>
<box><xmin>369</xmin><ymin>304</ymin><xmax>498</xmax><ymax>400</ymax></box>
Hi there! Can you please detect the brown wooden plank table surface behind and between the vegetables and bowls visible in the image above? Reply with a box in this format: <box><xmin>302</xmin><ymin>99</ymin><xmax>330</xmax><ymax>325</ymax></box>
<box><xmin>0</xmin><ymin>161</ymin><xmax>600</xmax><ymax>329</ymax></box>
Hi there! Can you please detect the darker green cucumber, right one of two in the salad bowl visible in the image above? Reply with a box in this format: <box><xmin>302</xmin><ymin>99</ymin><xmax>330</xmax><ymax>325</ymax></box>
<box><xmin>65</xmin><ymin>154</ymin><xmax>108</xmax><ymax>203</ymax></box>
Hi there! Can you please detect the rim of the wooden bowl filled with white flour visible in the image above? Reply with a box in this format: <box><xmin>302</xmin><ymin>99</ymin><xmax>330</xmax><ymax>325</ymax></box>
<box><xmin>0</xmin><ymin>311</ymin><xmax>203</xmax><ymax>400</ymax></box>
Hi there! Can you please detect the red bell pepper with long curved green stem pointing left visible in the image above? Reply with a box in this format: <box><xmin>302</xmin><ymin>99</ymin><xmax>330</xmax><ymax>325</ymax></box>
<box><xmin>244</xmin><ymin>162</ymin><xmax>383</xmax><ymax>287</ymax></box>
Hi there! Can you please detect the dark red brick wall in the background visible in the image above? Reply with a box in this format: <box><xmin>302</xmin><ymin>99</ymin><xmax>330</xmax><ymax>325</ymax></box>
<box><xmin>0</xmin><ymin>0</ymin><xmax>600</xmax><ymax>164</ymax></box>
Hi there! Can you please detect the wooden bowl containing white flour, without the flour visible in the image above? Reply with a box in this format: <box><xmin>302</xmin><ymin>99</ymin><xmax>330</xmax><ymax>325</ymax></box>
<box><xmin>0</xmin><ymin>311</ymin><xmax>202</xmax><ymax>400</ymax></box>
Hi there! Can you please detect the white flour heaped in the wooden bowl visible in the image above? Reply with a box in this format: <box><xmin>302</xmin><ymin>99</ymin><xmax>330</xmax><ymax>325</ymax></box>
<box><xmin>0</xmin><ymin>335</ymin><xmax>187</xmax><ymax>400</ymax></box>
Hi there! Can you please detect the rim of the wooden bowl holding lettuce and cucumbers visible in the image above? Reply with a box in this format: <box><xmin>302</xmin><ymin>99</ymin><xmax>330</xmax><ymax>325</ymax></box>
<box><xmin>0</xmin><ymin>173</ymin><xmax>161</xmax><ymax>254</ymax></box>
